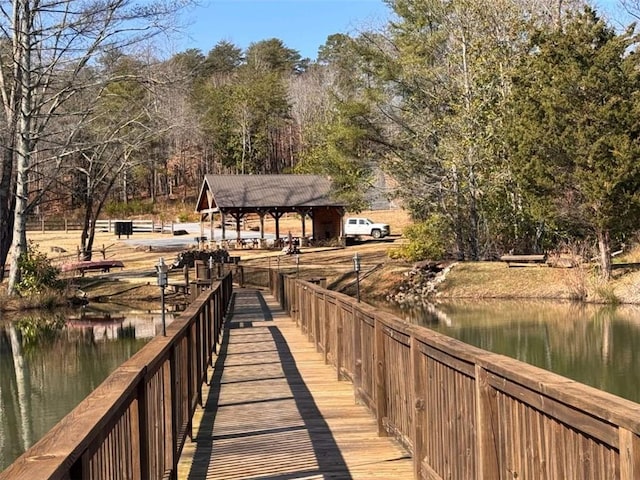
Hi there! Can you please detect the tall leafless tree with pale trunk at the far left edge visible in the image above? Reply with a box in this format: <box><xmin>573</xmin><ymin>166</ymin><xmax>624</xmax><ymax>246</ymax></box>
<box><xmin>0</xmin><ymin>0</ymin><xmax>190</xmax><ymax>294</ymax></box>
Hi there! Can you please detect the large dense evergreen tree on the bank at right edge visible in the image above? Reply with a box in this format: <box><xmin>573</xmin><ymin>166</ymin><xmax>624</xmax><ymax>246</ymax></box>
<box><xmin>511</xmin><ymin>8</ymin><xmax>640</xmax><ymax>278</ymax></box>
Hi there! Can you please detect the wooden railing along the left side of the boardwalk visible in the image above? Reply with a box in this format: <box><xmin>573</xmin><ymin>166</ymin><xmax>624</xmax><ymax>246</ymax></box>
<box><xmin>0</xmin><ymin>274</ymin><xmax>232</xmax><ymax>480</ymax></box>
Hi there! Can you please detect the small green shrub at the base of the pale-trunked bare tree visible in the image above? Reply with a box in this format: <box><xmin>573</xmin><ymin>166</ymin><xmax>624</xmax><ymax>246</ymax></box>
<box><xmin>16</xmin><ymin>242</ymin><xmax>61</xmax><ymax>295</ymax></box>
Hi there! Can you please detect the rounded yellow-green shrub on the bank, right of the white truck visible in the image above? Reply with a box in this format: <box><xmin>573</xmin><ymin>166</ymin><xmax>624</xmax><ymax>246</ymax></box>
<box><xmin>394</xmin><ymin>215</ymin><xmax>450</xmax><ymax>262</ymax></box>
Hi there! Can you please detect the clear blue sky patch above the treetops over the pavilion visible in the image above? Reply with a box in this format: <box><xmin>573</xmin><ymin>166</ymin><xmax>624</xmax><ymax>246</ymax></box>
<box><xmin>177</xmin><ymin>0</ymin><xmax>390</xmax><ymax>60</ymax></box>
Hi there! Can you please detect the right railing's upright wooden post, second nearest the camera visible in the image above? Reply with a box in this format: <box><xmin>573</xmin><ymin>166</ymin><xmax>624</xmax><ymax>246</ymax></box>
<box><xmin>476</xmin><ymin>365</ymin><xmax>500</xmax><ymax>480</ymax></box>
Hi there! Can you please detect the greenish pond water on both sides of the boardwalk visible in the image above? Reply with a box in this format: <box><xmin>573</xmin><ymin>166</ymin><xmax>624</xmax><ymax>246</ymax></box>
<box><xmin>6</xmin><ymin>300</ymin><xmax>640</xmax><ymax>470</ymax></box>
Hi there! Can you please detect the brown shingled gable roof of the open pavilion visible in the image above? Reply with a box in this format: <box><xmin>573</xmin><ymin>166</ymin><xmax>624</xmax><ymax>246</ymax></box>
<box><xmin>197</xmin><ymin>175</ymin><xmax>343</xmax><ymax>212</ymax></box>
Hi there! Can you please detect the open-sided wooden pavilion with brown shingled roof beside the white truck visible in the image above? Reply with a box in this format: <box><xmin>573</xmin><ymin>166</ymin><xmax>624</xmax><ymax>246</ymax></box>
<box><xmin>196</xmin><ymin>174</ymin><xmax>345</xmax><ymax>246</ymax></box>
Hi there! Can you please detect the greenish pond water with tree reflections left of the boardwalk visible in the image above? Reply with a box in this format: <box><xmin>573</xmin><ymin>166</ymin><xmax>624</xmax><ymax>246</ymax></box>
<box><xmin>0</xmin><ymin>306</ymin><xmax>173</xmax><ymax>471</ymax></box>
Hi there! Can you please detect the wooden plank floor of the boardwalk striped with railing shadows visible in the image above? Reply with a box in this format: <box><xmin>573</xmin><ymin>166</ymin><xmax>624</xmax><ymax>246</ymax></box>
<box><xmin>178</xmin><ymin>289</ymin><xmax>413</xmax><ymax>480</ymax></box>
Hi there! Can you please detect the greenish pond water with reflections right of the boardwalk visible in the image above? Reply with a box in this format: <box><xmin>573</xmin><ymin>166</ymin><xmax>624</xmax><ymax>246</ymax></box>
<box><xmin>380</xmin><ymin>300</ymin><xmax>640</xmax><ymax>402</ymax></box>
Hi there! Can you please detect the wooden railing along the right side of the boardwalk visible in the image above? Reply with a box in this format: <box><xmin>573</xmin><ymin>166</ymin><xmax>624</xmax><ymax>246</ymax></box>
<box><xmin>270</xmin><ymin>272</ymin><xmax>640</xmax><ymax>480</ymax></box>
